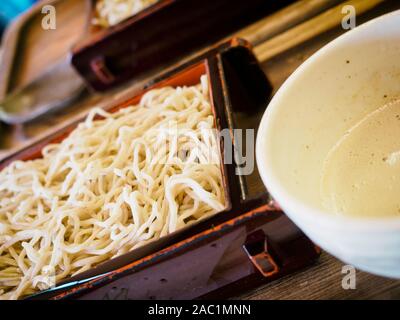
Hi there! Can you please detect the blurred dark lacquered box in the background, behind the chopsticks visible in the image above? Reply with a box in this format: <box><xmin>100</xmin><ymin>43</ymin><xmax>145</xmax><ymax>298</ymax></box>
<box><xmin>72</xmin><ymin>0</ymin><xmax>294</xmax><ymax>91</ymax></box>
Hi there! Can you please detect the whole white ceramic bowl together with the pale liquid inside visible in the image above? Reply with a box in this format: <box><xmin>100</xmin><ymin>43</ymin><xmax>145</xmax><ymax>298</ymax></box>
<box><xmin>256</xmin><ymin>11</ymin><xmax>400</xmax><ymax>278</ymax></box>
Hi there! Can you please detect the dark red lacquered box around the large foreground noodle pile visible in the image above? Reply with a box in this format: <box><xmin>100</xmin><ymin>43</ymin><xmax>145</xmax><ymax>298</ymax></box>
<box><xmin>0</xmin><ymin>39</ymin><xmax>319</xmax><ymax>299</ymax></box>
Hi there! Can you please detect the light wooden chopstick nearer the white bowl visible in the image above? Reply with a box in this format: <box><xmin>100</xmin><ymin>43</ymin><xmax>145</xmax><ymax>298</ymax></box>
<box><xmin>254</xmin><ymin>0</ymin><xmax>384</xmax><ymax>62</ymax></box>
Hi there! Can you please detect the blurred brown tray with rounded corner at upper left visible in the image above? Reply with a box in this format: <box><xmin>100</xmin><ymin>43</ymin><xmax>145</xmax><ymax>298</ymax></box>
<box><xmin>0</xmin><ymin>0</ymin><xmax>89</xmax><ymax>124</ymax></box>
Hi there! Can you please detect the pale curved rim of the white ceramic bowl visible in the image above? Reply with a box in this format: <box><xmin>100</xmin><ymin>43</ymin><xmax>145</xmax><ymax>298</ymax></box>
<box><xmin>256</xmin><ymin>10</ymin><xmax>400</xmax><ymax>232</ymax></box>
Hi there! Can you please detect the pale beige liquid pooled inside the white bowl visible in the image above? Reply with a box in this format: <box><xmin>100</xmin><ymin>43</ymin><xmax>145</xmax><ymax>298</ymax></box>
<box><xmin>321</xmin><ymin>100</ymin><xmax>400</xmax><ymax>217</ymax></box>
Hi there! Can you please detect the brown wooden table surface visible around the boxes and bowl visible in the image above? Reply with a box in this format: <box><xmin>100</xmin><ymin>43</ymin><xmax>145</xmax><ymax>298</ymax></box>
<box><xmin>0</xmin><ymin>0</ymin><xmax>400</xmax><ymax>299</ymax></box>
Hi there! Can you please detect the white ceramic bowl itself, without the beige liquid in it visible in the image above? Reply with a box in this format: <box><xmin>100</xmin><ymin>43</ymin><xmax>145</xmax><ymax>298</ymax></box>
<box><xmin>256</xmin><ymin>11</ymin><xmax>400</xmax><ymax>278</ymax></box>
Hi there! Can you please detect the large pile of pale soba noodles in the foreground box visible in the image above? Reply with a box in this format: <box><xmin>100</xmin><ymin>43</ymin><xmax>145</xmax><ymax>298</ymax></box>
<box><xmin>0</xmin><ymin>76</ymin><xmax>225</xmax><ymax>299</ymax></box>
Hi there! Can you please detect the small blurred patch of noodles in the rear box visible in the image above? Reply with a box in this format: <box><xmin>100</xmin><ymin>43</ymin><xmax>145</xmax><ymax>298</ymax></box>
<box><xmin>93</xmin><ymin>0</ymin><xmax>159</xmax><ymax>28</ymax></box>
